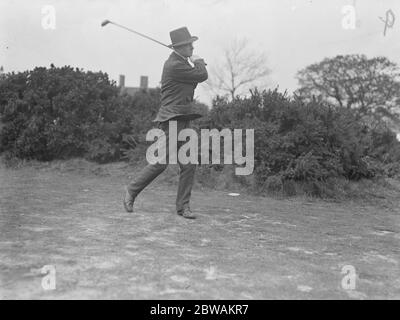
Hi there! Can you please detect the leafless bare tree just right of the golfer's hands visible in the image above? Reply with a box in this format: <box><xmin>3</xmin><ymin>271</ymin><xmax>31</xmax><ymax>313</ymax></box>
<box><xmin>207</xmin><ymin>38</ymin><xmax>270</xmax><ymax>100</ymax></box>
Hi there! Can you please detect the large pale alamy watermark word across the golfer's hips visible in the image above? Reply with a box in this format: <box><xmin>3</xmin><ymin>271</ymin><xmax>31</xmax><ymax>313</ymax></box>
<box><xmin>146</xmin><ymin>121</ymin><xmax>254</xmax><ymax>175</ymax></box>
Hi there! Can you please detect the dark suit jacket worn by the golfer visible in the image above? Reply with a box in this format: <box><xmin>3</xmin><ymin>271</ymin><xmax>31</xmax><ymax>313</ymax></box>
<box><xmin>154</xmin><ymin>52</ymin><xmax>208</xmax><ymax>122</ymax></box>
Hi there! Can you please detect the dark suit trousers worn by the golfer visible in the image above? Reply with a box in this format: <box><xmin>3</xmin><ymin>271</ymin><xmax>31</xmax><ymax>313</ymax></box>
<box><xmin>128</xmin><ymin>120</ymin><xmax>196</xmax><ymax>212</ymax></box>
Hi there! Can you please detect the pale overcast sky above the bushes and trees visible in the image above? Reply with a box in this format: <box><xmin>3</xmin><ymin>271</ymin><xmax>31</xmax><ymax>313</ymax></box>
<box><xmin>0</xmin><ymin>0</ymin><xmax>400</xmax><ymax>103</ymax></box>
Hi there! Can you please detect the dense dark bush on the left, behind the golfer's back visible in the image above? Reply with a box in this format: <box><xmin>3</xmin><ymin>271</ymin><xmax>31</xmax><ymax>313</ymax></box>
<box><xmin>0</xmin><ymin>66</ymin><xmax>159</xmax><ymax>162</ymax></box>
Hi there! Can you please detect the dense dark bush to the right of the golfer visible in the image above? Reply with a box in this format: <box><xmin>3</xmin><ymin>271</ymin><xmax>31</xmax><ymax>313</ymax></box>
<box><xmin>208</xmin><ymin>90</ymin><xmax>400</xmax><ymax>189</ymax></box>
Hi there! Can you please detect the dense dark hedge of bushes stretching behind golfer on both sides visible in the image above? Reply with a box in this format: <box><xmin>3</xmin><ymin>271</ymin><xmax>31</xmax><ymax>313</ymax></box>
<box><xmin>0</xmin><ymin>67</ymin><xmax>400</xmax><ymax>193</ymax></box>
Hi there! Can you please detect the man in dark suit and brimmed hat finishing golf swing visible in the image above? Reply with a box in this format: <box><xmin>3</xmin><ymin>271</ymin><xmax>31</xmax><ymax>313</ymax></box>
<box><xmin>123</xmin><ymin>27</ymin><xmax>208</xmax><ymax>219</ymax></box>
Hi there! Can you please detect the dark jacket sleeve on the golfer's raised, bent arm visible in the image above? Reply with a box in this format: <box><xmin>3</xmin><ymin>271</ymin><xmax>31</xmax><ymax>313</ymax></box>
<box><xmin>170</xmin><ymin>59</ymin><xmax>208</xmax><ymax>84</ymax></box>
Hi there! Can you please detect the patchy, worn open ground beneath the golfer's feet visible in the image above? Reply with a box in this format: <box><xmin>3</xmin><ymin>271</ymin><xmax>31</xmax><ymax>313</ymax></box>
<box><xmin>0</xmin><ymin>162</ymin><xmax>400</xmax><ymax>299</ymax></box>
